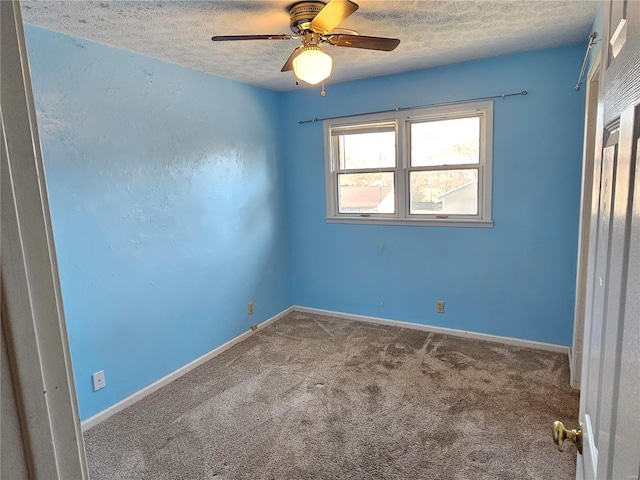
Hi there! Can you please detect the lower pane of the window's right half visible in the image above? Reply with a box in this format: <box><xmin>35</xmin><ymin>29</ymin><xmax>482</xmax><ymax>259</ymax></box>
<box><xmin>409</xmin><ymin>168</ymin><xmax>478</xmax><ymax>215</ymax></box>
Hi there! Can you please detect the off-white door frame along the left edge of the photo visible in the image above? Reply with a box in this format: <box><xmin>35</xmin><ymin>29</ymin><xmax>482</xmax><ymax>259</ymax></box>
<box><xmin>0</xmin><ymin>1</ymin><xmax>89</xmax><ymax>480</ymax></box>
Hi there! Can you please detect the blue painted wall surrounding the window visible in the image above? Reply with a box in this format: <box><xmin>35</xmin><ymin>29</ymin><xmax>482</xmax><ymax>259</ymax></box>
<box><xmin>283</xmin><ymin>44</ymin><xmax>584</xmax><ymax>345</ymax></box>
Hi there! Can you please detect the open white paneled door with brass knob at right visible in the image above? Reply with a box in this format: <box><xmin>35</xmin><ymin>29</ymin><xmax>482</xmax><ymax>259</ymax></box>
<box><xmin>577</xmin><ymin>0</ymin><xmax>640</xmax><ymax>480</ymax></box>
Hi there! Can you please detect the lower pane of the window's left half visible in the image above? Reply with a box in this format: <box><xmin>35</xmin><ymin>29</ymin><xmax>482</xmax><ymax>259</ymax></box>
<box><xmin>338</xmin><ymin>172</ymin><xmax>396</xmax><ymax>213</ymax></box>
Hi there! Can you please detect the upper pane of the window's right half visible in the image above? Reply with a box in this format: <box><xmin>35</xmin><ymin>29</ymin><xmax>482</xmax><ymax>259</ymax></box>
<box><xmin>411</xmin><ymin>117</ymin><xmax>480</xmax><ymax>167</ymax></box>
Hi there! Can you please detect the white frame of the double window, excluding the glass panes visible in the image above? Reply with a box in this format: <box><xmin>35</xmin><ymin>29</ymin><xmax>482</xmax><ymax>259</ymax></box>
<box><xmin>323</xmin><ymin>101</ymin><xmax>493</xmax><ymax>228</ymax></box>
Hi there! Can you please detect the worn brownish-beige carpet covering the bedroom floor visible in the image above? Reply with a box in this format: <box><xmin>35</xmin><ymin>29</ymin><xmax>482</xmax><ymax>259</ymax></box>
<box><xmin>85</xmin><ymin>312</ymin><xmax>579</xmax><ymax>480</ymax></box>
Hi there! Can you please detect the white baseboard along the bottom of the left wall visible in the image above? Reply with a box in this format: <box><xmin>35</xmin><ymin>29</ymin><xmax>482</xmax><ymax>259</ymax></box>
<box><xmin>81</xmin><ymin>307</ymin><xmax>293</xmax><ymax>432</ymax></box>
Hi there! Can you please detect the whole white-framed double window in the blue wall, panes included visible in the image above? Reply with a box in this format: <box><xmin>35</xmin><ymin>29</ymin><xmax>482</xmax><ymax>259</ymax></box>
<box><xmin>324</xmin><ymin>102</ymin><xmax>493</xmax><ymax>227</ymax></box>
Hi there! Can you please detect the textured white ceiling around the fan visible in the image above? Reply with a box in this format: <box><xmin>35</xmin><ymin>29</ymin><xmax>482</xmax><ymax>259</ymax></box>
<box><xmin>22</xmin><ymin>0</ymin><xmax>598</xmax><ymax>90</ymax></box>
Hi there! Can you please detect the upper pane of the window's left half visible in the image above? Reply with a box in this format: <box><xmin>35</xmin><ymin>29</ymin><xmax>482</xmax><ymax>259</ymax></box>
<box><xmin>334</xmin><ymin>132</ymin><xmax>396</xmax><ymax>170</ymax></box>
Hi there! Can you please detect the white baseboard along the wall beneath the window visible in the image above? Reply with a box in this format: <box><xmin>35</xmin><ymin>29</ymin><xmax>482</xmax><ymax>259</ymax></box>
<box><xmin>293</xmin><ymin>305</ymin><xmax>569</xmax><ymax>355</ymax></box>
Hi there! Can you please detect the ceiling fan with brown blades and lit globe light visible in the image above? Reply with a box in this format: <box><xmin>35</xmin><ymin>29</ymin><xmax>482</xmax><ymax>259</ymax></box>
<box><xmin>211</xmin><ymin>0</ymin><xmax>400</xmax><ymax>85</ymax></box>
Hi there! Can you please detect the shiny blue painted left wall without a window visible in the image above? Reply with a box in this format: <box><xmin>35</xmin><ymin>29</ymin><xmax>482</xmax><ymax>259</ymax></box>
<box><xmin>25</xmin><ymin>25</ymin><xmax>292</xmax><ymax>419</ymax></box>
